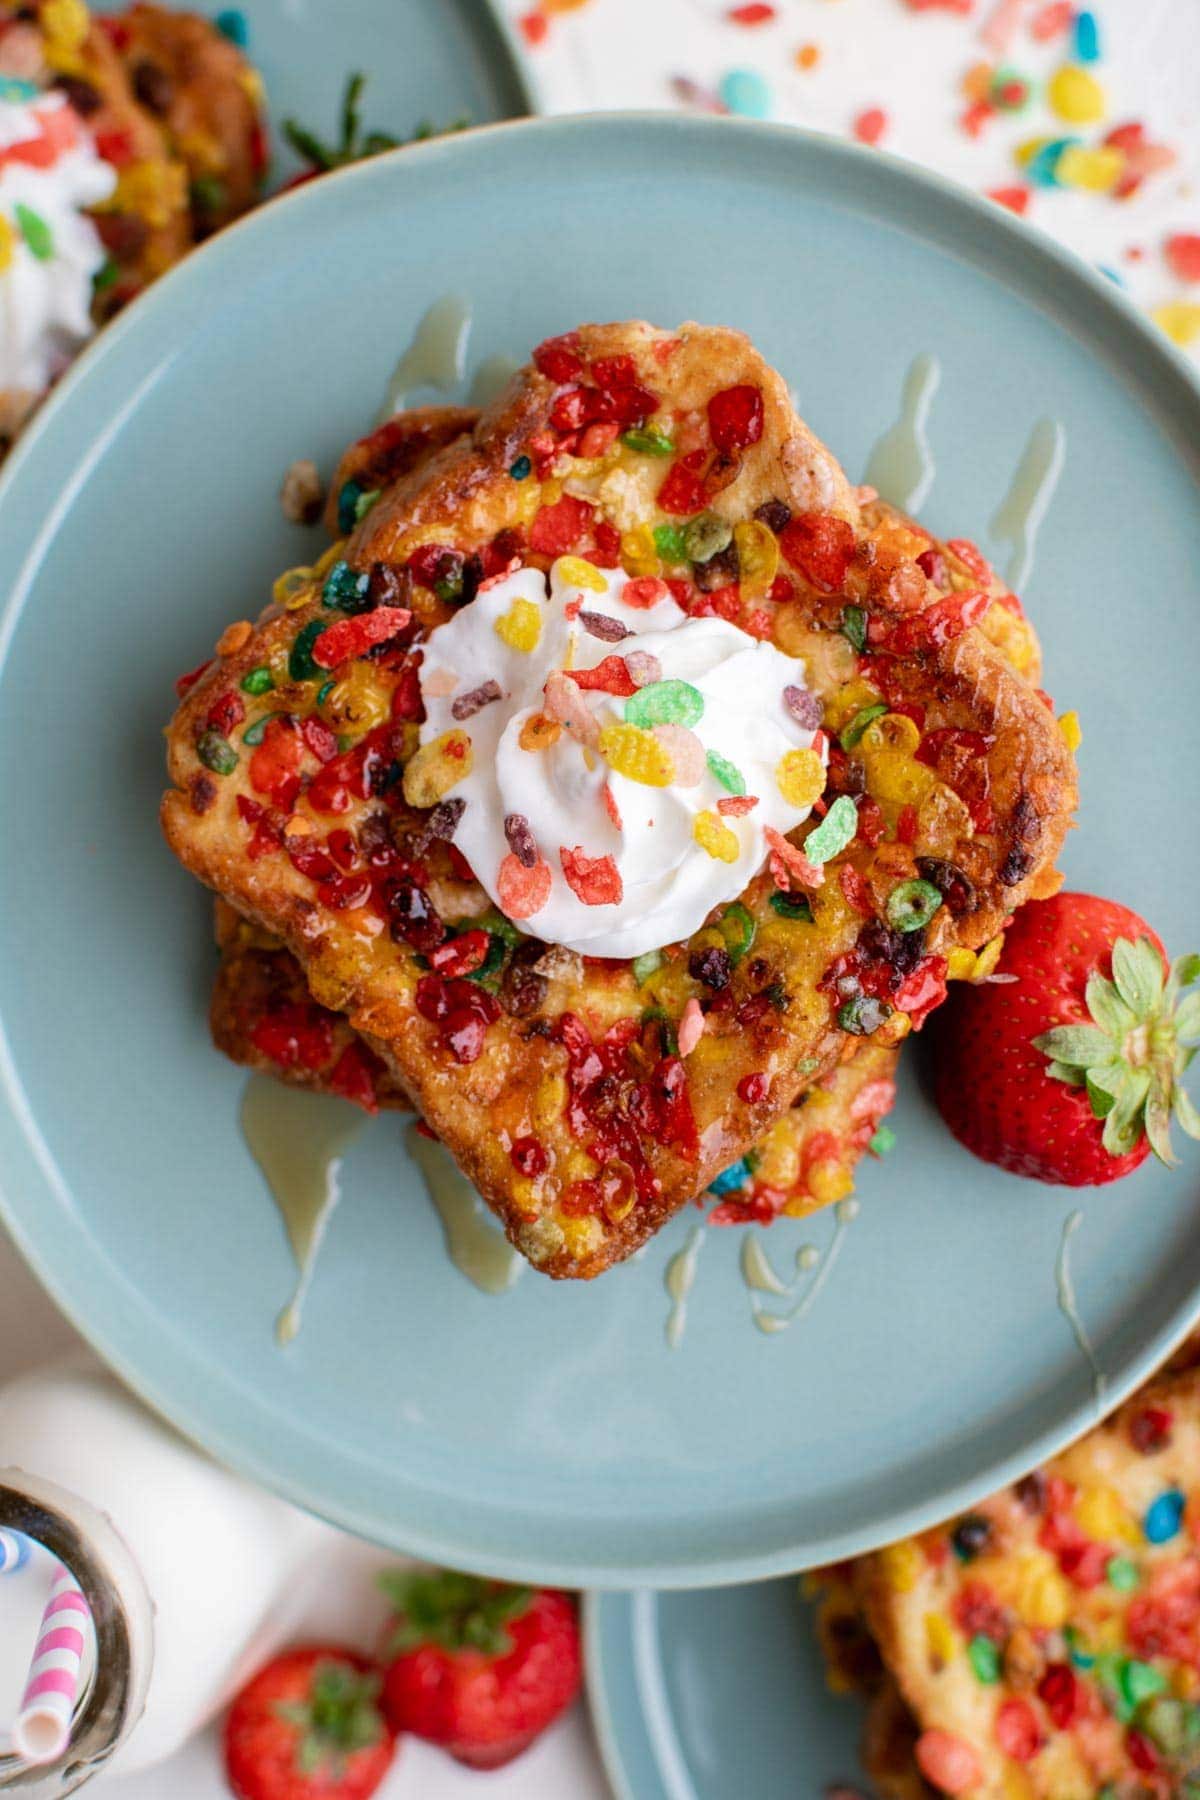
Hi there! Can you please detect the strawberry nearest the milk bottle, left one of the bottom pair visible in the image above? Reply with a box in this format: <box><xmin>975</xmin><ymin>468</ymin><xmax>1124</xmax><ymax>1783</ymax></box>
<box><xmin>225</xmin><ymin>1643</ymin><xmax>396</xmax><ymax>1800</ymax></box>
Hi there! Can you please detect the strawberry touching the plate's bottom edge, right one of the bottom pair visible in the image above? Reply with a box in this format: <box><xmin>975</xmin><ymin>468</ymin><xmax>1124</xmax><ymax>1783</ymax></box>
<box><xmin>381</xmin><ymin>1571</ymin><xmax>581</xmax><ymax>1769</ymax></box>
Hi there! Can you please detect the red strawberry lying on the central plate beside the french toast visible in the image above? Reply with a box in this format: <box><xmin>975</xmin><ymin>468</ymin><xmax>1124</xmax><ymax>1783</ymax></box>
<box><xmin>932</xmin><ymin>893</ymin><xmax>1200</xmax><ymax>1188</ymax></box>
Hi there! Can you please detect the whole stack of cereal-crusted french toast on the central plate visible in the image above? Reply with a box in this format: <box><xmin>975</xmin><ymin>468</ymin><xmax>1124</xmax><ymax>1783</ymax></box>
<box><xmin>162</xmin><ymin>322</ymin><xmax>1076</xmax><ymax>1278</ymax></box>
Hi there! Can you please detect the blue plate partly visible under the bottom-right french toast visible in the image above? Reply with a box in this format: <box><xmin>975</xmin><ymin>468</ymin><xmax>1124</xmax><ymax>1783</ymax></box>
<box><xmin>585</xmin><ymin>1580</ymin><xmax>864</xmax><ymax>1800</ymax></box>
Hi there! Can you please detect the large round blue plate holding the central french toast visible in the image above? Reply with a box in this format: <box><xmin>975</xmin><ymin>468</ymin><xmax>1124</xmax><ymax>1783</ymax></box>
<box><xmin>0</xmin><ymin>115</ymin><xmax>1200</xmax><ymax>1586</ymax></box>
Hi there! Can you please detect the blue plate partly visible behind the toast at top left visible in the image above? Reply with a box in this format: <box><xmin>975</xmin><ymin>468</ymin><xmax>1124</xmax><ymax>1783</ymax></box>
<box><xmin>92</xmin><ymin>0</ymin><xmax>533</xmax><ymax>162</ymax></box>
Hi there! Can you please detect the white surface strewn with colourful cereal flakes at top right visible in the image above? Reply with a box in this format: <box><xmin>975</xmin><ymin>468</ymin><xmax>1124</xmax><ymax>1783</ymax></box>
<box><xmin>504</xmin><ymin>0</ymin><xmax>1200</xmax><ymax>367</ymax></box>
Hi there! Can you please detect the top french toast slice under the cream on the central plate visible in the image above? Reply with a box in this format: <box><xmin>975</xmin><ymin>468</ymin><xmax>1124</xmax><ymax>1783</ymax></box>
<box><xmin>162</xmin><ymin>324</ymin><xmax>1076</xmax><ymax>1276</ymax></box>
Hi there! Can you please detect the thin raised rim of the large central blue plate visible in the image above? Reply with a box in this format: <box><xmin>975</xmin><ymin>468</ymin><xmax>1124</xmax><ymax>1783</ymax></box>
<box><xmin>0</xmin><ymin>110</ymin><xmax>1200</xmax><ymax>1589</ymax></box>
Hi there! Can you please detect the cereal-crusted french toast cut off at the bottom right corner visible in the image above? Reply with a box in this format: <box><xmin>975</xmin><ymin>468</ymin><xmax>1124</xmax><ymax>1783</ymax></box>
<box><xmin>822</xmin><ymin>1348</ymin><xmax>1200</xmax><ymax>1800</ymax></box>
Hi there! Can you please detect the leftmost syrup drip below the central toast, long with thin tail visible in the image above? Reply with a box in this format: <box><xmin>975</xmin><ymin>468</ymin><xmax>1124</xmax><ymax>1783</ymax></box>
<box><xmin>241</xmin><ymin>1075</ymin><xmax>367</xmax><ymax>1345</ymax></box>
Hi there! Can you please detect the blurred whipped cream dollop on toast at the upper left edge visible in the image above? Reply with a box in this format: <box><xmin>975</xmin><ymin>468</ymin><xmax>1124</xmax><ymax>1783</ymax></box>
<box><xmin>0</xmin><ymin>77</ymin><xmax>117</xmax><ymax>394</ymax></box>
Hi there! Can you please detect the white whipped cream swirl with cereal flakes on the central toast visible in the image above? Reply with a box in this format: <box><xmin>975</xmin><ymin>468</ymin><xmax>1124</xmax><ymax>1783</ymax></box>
<box><xmin>417</xmin><ymin>556</ymin><xmax>828</xmax><ymax>958</ymax></box>
